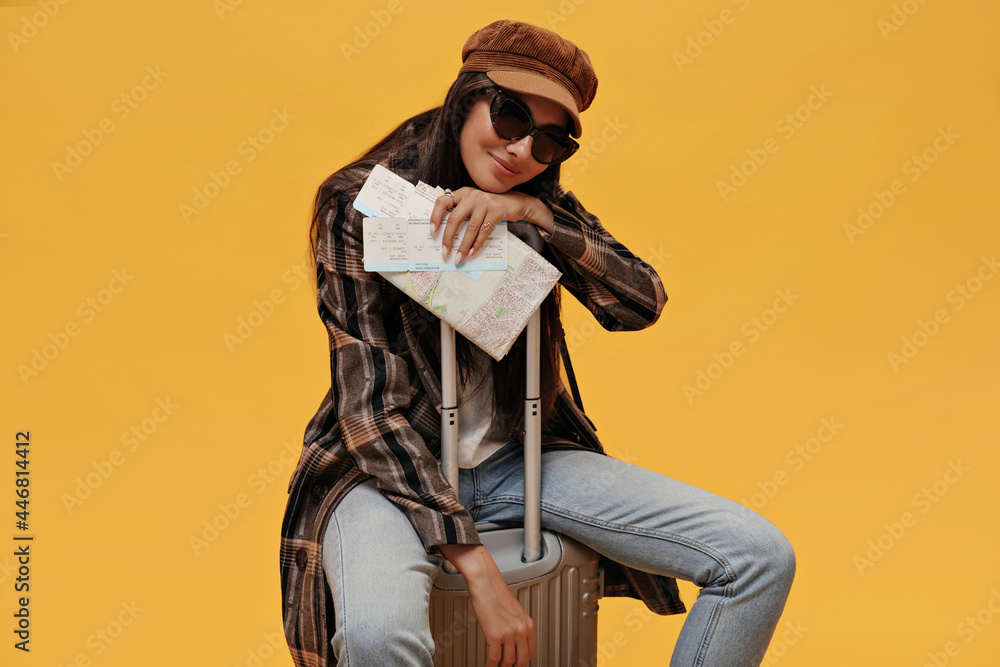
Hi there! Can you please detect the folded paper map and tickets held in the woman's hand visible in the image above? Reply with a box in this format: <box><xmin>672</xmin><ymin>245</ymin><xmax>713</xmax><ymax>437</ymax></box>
<box><xmin>353</xmin><ymin>166</ymin><xmax>561</xmax><ymax>360</ymax></box>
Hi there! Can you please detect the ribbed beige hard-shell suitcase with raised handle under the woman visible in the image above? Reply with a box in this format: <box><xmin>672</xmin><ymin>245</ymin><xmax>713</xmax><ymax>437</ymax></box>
<box><xmin>430</xmin><ymin>225</ymin><xmax>604</xmax><ymax>667</ymax></box>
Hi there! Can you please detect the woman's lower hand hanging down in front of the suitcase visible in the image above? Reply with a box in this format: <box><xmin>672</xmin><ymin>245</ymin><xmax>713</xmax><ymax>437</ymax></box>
<box><xmin>439</xmin><ymin>544</ymin><xmax>535</xmax><ymax>667</ymax></box>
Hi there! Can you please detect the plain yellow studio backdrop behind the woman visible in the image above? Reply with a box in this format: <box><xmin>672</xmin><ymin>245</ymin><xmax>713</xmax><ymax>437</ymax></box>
<box><xmin>0</xmin><ymin>0</ymin><xmax>1000</xmax><ymax>667</ymax></box>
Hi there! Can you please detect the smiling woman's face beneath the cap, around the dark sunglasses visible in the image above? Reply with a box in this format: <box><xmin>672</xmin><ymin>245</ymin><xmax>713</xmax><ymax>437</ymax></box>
<box><xmin>459</xmin><ymin>93</ymin><xmax>569</xmax><ymax>194</ymax></box>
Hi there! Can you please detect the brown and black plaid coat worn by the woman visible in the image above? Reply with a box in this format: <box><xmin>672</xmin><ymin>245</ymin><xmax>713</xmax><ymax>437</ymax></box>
<box><xmin>280</xmin><ymin>154</ymin><xmax>686</xmax><ymax>667</ymax></box>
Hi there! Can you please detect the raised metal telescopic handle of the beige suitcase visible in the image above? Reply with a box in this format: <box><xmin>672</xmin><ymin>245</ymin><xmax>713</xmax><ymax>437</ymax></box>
<box><xmin>441</xmin><ymin>223</ymin><xmax>544</xmax><ymax>570</ymax></box>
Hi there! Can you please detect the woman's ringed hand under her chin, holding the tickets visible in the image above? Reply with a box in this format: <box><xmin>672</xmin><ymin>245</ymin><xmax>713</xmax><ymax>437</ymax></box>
<box><xmin>431</xmin><ymin>188</ymin><xmax>553</xmax><ymax>264</ymax></box>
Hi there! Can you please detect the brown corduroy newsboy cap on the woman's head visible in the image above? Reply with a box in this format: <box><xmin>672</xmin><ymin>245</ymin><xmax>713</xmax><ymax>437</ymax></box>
<box><xmin>459</xmin><ymin>20</ymin><xmax>597</xmax><ymax>137</ymax></box>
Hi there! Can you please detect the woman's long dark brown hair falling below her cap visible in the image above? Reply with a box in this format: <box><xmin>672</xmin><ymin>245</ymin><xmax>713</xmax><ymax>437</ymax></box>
<box><xmin>309</xmin><ymin>72</ymin><xmax>563</xmax><ymax>437</ymax></box>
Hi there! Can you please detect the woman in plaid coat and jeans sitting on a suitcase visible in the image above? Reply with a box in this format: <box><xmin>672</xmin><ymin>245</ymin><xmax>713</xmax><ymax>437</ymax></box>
<box><xmin>281</xmin><ymin>21</ymin><xmax>795</xmax><ymax>667</ymax></box>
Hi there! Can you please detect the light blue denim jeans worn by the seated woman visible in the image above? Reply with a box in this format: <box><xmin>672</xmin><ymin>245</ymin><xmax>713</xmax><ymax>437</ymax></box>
<box><xmin>323</xmin><ymin>443</ymin><xmax>795</xmax><ymax>667</ymax></box>
